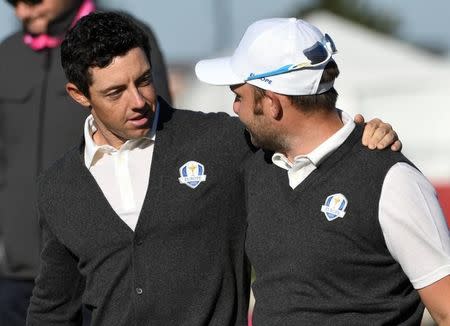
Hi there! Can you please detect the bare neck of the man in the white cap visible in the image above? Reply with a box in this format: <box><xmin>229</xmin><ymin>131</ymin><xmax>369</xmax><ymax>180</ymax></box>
<box><xmin>284</xmin><ymin>110</ymin><xmax>344</xmax><ymax>162</ymax></box>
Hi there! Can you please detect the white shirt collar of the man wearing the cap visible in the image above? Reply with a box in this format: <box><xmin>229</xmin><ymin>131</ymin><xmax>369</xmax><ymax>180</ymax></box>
<box><xmin>272</xmin><ymin>111</ymin><xmax>355</xmax><ymax>170</ymax></box>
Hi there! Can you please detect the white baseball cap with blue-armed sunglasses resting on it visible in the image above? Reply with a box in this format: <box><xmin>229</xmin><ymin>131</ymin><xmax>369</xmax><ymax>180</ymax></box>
<box><xmin>195</xmin><ymin>18</ymin><xmax>337</xmax><ymax>95</ymax></box>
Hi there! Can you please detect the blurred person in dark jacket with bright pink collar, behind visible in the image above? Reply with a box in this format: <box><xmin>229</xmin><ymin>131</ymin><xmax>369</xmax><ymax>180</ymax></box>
<box><xmin>0</xmin><ymin>0</ymin><xmax>170</xmax><ymax>326</ymax></box>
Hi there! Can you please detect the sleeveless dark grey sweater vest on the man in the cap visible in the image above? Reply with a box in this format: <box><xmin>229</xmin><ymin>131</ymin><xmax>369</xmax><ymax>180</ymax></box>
<box><xmin>246</xmin><ymin>126</ymin><xmax>423</xmax><ymax>326</ymax></box>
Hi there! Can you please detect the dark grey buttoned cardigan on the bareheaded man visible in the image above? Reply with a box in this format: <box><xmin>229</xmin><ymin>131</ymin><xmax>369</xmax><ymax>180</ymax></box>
<box><xmin>27</xmin><ymin>102</ymin><xmax>249</xmax><ymax>326</ymax></box>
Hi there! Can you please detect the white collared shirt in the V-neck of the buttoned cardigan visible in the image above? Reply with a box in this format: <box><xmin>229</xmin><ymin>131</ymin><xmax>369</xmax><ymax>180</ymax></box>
<box><xmin>84</xmin><ymin>104</ymin><xmax>159</xmax><ymax>231</ymax></box>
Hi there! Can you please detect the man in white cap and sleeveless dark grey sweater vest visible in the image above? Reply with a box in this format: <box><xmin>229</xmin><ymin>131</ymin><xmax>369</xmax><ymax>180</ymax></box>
<box><xmin>196</xmin><ymin>18</ymin><xmax>450</xmax><ymax>326</ymax></box>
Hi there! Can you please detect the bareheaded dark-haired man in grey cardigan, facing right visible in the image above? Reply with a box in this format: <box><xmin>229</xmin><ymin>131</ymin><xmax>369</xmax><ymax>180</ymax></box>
<box><xmin>27</xmin><ymin>13</ymin><xmax>393</xmax><ymax>326</ymax></box>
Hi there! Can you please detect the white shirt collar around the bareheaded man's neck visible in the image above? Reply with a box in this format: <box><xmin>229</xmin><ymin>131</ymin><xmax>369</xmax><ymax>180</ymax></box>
<box><xmin>84</xmin><ymin>101</ymin><xmax>159</xmax><ymax>168</ymax></box>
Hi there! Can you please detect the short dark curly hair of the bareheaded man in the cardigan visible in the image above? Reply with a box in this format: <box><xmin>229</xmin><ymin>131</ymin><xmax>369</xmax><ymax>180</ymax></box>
<box><xmin>61</xmin><ymin>12</ymin><xmax>151</xmax><ymax>98</ymax></box>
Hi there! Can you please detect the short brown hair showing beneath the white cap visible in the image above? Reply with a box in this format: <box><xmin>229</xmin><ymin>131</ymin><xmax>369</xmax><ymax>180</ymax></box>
<box><xmin>255</xmin><ymin>60</ymin><xmax>339</xmax><ymax>112</ymax></box>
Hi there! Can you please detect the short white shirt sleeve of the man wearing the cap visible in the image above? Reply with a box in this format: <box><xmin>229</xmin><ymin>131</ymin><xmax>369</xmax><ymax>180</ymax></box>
<box><xmin>378</xmin><ymin>163</ymin><xmax>450</xmax><ymax>289</ymax></box>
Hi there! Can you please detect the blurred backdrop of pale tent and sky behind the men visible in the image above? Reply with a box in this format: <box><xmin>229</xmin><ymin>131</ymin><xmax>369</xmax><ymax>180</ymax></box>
<box><xmin>0</xmin><ymin>0</ymin><xmax>450</xmax><ymax>324</ymax></box>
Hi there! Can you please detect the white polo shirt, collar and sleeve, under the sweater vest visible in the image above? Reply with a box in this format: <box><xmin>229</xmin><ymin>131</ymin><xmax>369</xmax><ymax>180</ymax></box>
<box><xmin>272</xmin><ymin>112</ymin><xmax>450</xmax><ymax>289</ymax></box>
